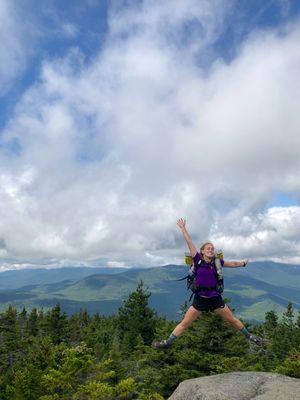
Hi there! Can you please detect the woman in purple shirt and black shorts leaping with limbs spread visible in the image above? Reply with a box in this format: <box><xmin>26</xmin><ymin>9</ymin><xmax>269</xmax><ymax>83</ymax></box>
<box><xmin>153</xmin><ymin>218</ymin><xmax>262</xmax><ymax>349</ymax></box>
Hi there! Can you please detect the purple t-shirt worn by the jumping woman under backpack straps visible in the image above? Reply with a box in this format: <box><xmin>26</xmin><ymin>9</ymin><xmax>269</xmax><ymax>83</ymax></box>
<box><xmin>194</xmin><ymin>253</ymin><xmax>224</xmax><ymax>297</ymax></box>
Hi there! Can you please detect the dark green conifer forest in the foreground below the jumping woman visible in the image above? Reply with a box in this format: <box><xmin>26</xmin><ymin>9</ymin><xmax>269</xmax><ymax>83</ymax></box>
<box><xmin>0</xmin><ymin>282</ymin><xmax>300</xmax><ymax>400</ymax></box>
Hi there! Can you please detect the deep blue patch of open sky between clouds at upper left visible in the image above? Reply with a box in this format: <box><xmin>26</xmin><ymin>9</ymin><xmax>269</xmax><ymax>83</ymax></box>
<box><xmin>0</xmin><ymin>0</ymin><xmax>108</xmax><ymax>126</ymax></box>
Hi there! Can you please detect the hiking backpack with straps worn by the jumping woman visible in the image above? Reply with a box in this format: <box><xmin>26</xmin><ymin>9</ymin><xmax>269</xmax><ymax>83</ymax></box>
<box><xmin>177</xmin><ymin>250</ymin><xmax>224</xmax><ymax>301</ymax></box>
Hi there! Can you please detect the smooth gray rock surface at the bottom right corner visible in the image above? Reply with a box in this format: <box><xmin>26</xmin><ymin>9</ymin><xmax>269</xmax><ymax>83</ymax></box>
<box><xmin>169</xmin><ymin>372</ymin><xmax>300</xmax><ymax>400</ymax></box>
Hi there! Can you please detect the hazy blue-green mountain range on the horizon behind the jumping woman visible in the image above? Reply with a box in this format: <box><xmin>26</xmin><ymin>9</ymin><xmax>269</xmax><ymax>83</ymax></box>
<box><xmin>0</xmin><ymin>262</ymin><xmax>300</xmax><ymax>322</ymax></box>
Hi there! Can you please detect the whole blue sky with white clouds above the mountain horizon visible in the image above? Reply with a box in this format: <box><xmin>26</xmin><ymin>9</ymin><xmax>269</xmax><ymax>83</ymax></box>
<box><xmin>0</xmin><ymin>0</ymin><xmax>300</xmax><ymax>271</ymax></box>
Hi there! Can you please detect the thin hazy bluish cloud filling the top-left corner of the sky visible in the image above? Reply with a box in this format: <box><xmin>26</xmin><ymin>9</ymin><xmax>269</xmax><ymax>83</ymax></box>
<box><xmin>0</xmin><ymin>0</ymin><xmax>78</xmax><ymax>96</ymax></box>
